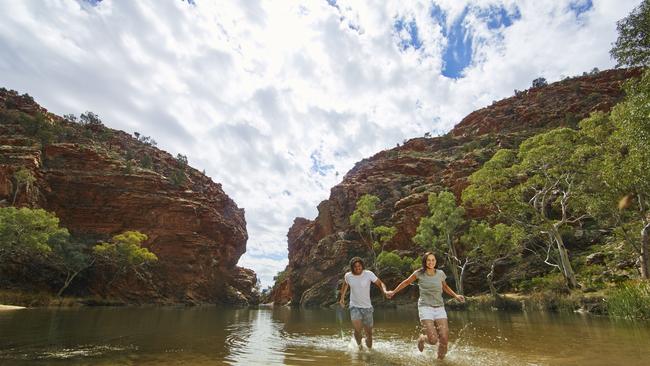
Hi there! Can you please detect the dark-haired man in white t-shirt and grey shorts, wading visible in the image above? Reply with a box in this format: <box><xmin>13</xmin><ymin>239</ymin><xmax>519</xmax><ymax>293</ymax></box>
<box><xmin>339</xmin><ymin>257</ymin><xmax>386</xmax><ymax>349</ymax></box>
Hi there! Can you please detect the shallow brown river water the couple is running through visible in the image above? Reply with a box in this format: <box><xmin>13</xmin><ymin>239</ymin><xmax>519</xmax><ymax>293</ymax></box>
<box><xmin>0</xmin><ymin>307</ymin><xmax>650</xmax><ymax>366</ymax></box>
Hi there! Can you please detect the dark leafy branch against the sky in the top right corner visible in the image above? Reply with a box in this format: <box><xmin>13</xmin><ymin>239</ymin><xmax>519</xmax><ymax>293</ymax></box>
<box><xmin>609</xmin><ymin>0</ymin><xmax>650</xmax><ymax>67</ymax></box>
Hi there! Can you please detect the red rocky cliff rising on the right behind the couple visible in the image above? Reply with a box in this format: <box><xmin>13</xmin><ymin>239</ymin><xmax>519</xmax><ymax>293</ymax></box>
<box><xmin>268</xmin><ymin>70</ymin><xmax>640</xmax><ymax>306</ymax></box>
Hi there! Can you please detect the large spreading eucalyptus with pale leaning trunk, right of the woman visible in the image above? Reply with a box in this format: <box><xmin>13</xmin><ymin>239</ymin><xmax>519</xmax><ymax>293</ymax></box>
<box><xmin>463</xmin><ymin>128</ymin><xmax>588</xmax><ymax>288</ymax></box>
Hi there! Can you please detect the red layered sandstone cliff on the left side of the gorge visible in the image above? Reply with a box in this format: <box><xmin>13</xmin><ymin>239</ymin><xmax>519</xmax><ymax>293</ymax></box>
<box><xmin>0</xmin><ymin>90</ymin><xmax>256</xmax><ymax>303</ymax></box>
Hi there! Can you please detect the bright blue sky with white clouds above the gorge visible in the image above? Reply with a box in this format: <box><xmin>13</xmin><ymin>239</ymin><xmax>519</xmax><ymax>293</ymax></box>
<box><xmin>0</xmin><ymin>0</ymin><xmax>640</xmax><ymax>287</ymax></box>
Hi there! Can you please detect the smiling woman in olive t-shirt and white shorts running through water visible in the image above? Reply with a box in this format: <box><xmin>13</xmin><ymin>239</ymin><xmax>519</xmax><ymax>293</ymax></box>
<box><xmin>386</xmin><ymin>252</ymin><xmax>465</xmax><ymax>360</ymax></box>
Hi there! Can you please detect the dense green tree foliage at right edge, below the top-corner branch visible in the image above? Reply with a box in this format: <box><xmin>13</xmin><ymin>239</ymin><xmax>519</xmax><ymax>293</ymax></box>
<box><xmin>580</xmin><ymin>71</ymin><xmax>650</xmax><ymax>278</ymax></box>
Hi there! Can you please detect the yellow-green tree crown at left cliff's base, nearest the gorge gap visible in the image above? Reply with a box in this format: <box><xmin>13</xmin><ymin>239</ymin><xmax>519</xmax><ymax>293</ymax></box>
<box><xmin>93</xmin><ymin>231</ymin><xmax>158</xmax><ymax>267</ymax></box>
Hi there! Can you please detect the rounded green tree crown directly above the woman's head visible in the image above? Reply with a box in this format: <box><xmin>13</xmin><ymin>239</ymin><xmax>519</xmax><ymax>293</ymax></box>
<box><xmin>413</xmin><ymin>191</ymin><xmax>465</xmax><ymax>252</ymax></box>
